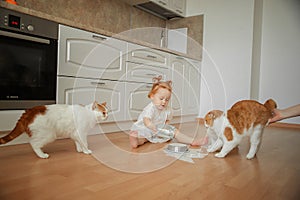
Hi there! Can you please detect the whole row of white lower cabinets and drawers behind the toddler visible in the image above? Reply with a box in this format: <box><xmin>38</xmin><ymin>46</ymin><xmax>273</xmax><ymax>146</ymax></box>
<box><xmin>57</xmin><ymin>26</ymin><xmax>200</xmax><ymax>126</ymax></box>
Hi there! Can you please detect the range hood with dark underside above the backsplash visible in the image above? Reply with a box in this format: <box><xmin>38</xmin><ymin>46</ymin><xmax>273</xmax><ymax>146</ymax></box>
<box><xmin>125</xmin><ymin>0</ymin><xmax>184</xmax><ymax>20</ymax></box>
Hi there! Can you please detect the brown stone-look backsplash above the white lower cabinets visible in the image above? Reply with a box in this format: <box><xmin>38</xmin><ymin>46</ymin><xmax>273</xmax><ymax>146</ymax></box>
<box><xmin>8</xmin><ymin>0</ymin><xmax>203</xmax><ymax>59</ymax></box>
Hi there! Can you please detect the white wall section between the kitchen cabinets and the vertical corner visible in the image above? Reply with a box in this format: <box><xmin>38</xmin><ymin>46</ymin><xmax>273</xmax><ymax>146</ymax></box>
<box><xmin>187</xmin><ymin>0</ymin><xmax>254</xmax><ymax>117</ymax></box>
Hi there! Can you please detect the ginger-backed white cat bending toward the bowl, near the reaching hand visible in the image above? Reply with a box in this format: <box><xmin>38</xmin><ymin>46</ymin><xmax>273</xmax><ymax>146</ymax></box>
<box><xmin>204</xmin><ymin>99</ymin><xmax>276</xmax><ymax>159</ymax></box>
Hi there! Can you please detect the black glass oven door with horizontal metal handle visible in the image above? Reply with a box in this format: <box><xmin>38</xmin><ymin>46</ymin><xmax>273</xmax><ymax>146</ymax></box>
<box><xmin>0</xmin><ymin>29</ymin><xmax>57</xmax><ymax>110</ymax></box>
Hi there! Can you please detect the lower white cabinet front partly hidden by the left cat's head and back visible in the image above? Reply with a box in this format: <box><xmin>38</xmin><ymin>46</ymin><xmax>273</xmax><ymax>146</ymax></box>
<box><xmin>57</xmin><ymin>77</ymin><xmax>125</xmax><ymax>122</ymax></box>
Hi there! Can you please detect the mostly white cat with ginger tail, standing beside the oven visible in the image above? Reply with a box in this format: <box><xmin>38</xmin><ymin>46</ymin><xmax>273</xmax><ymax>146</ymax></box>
<box><xmin>0</xmin><ymin>102</ymin><xmax>108</xmax><ymax>158</ymax></box>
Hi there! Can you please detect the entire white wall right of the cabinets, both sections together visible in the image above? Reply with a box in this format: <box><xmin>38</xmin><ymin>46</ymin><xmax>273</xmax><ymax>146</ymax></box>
<box><xmin>187</xmin><ymin>0</ymin><xmax>300</xmax><ymax>124</ymax></box>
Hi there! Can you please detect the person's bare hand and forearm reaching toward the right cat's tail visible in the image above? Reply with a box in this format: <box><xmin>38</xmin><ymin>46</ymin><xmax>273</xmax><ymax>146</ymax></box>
<box><xmin>270</xmin><ymin>104</ymin><xmax>300</xmax><ymax>123</ymax></box>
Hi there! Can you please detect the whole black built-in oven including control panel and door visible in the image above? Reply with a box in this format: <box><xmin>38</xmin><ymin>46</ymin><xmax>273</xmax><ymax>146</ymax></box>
<box><xmin>0</xmin><ymin>8</ymin><xmax>58</xmax><ymax>110</ymax></box>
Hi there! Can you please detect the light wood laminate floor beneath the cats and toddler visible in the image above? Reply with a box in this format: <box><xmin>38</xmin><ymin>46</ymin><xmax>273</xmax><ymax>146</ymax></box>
<box><xmin>0</xmin><ymin>122</ymin><xmax>300</xmax><ymax>200</ymax></box>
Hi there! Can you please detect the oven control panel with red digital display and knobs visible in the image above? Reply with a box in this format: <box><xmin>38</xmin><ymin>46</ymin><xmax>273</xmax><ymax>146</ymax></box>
<box><xmin>0</xmin><ymin>8</ymin><xmax>58</xmax><ymax>39</ymax></box>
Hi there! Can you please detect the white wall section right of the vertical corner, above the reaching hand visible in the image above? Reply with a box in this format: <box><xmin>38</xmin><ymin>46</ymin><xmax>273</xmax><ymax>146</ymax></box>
<box><xmin>259</xmin><ymin>0</ymin><xmax>300</xmax><ymax>124</ymax></box>
